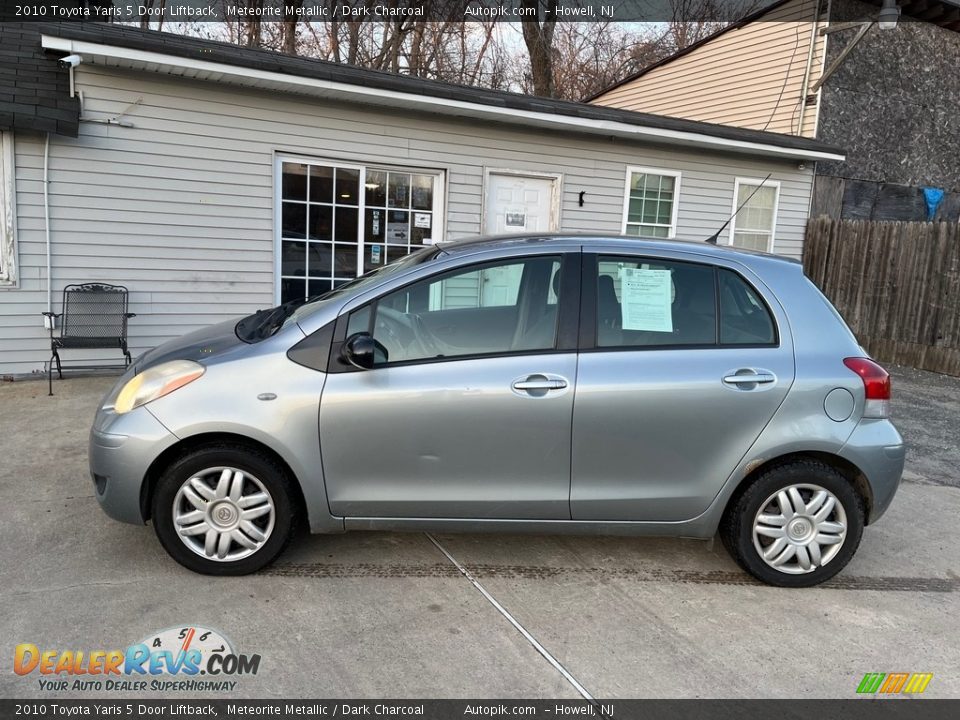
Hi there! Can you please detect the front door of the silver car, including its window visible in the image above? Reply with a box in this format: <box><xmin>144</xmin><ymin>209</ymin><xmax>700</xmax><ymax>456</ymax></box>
<box><xmin>320</xmin><ymin>252</ymin><xmax>579</xmax><ymax>519</ymax></box>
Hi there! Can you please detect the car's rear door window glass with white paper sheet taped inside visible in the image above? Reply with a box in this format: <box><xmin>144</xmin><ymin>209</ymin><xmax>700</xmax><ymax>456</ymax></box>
<box><xmin>597</xmin><ymin>257</ymin><xmax>717</xmax><ymax>347</ymax></box>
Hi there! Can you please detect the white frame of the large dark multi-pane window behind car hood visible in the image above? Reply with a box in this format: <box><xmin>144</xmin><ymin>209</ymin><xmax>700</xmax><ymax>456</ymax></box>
<box><xmin>273</xmin><ymin>152</ymin><xmax>448</xmax><ymax>304</ymax></box>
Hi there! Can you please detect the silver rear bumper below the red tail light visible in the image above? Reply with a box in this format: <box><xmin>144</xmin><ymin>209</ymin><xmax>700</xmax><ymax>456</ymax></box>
<box><xmin>839</xmin><ymin>418</ymin><xmax>906</xmax><ymax>525</ymax></box>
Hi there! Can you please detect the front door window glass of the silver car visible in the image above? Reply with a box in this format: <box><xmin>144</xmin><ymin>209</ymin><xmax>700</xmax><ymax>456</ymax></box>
<box><xmin>347</xmin><ymin>256</ymin><xmax>561</xmax><ymax>365</ymax></box>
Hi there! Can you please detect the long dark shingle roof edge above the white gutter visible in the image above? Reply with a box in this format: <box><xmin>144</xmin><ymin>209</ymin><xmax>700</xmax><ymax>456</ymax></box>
<box><xmin>41</xmin><ymin>23</ymin><xmax>843</xmax><ymax>159</ymax></box>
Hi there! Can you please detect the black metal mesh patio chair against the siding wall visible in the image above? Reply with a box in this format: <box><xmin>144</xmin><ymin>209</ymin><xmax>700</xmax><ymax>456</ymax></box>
<box><xmin>43</xmin><ymin>283</ymin><xmax>136</xmax><ymax>395</ymax></box>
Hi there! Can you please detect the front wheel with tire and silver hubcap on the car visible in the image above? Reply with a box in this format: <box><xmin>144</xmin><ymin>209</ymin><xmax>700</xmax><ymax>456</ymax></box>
<box><xmin>152</xmin><ymin>444</ymin><xmax>299</xmax><ymax>575</ymax></box>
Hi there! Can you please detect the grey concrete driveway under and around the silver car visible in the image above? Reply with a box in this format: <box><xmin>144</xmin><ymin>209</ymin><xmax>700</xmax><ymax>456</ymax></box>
<box><xmin>0</xmin><ymin>370</ymin><xmax>960</xmax><ymax>698</ymax></box>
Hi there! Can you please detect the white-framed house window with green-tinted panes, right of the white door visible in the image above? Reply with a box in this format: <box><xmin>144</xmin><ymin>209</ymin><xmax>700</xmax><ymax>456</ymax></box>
<box><xmin>623</xmin><ymin>168</ymin><xmax>680</xmax><ymax>238</ymax></box>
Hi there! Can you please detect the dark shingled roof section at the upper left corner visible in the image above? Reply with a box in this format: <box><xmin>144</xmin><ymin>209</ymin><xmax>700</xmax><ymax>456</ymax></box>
<box><xmin>0</xmin><ymin>23</ymin><xmax>80</xmax><ymax>137</ymax></box>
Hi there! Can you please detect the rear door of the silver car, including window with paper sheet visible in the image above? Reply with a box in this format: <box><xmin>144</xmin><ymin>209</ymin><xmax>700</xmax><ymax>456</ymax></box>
<box><xmin>570</xmin><ymin>253</ymin><xmax>794</xmax><ymax>521</ymax></box>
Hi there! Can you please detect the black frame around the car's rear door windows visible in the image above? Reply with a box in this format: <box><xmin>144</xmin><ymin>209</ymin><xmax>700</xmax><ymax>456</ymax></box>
<box><xmin>578</xmin><ymin>253</ymin><xmax>782</xmax><ymax>352</ymax></box>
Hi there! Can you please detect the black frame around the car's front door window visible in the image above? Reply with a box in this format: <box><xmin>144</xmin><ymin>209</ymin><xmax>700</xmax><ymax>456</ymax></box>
<box><xmin>327</xmin><ymin>250</ymin><xmax>583</xmax><ymax>373</ymax></box>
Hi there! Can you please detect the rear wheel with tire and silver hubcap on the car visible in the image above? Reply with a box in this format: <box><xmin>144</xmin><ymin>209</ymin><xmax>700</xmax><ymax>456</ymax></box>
<box><xmin>720</xmin><ymin>460</ymin><xmax>865</xmax><ymax>587</ymax></box>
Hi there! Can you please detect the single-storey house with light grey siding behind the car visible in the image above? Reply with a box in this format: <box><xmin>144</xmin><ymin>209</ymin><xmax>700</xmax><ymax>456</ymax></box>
<box><xmin>0</xmin><ymin>26</ymin><xmax>842</xmax><ymax>374</ymax></box>
